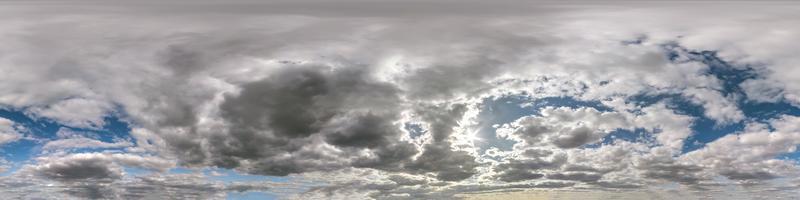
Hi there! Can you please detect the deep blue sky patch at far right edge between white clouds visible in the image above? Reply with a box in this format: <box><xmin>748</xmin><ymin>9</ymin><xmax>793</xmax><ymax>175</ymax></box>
<box><xmin>648</xmin><ymin>43</ymin><xmax>800</xmax><ymax>153</ymax></box>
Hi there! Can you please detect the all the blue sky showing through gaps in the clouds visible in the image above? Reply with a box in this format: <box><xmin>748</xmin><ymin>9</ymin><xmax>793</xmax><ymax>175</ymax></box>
<box><xmin>6</xmin><ymin>41</ymin><xmax>800</xmax><ymax>199</ymax></box>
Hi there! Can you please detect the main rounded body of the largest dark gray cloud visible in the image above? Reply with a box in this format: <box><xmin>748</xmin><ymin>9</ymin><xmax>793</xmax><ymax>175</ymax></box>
<box><xmin>209</xmin><ymin>66</ymin><xmax>416</xmax><ymax>175</ymax></box>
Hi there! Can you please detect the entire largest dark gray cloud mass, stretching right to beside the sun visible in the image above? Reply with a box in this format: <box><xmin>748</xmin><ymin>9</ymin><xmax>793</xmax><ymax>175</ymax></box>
<box><xmin>146</xmin><ymin>63</ymin><xmax>478</xmax><ymax>181</ymax></box>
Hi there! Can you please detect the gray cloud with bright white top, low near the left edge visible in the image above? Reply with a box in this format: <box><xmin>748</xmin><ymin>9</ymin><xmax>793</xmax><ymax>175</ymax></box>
<box><xmin>2</xmin><ymin>152</ymin><xmax>179</xmax><ymax>199</ymax></box>
